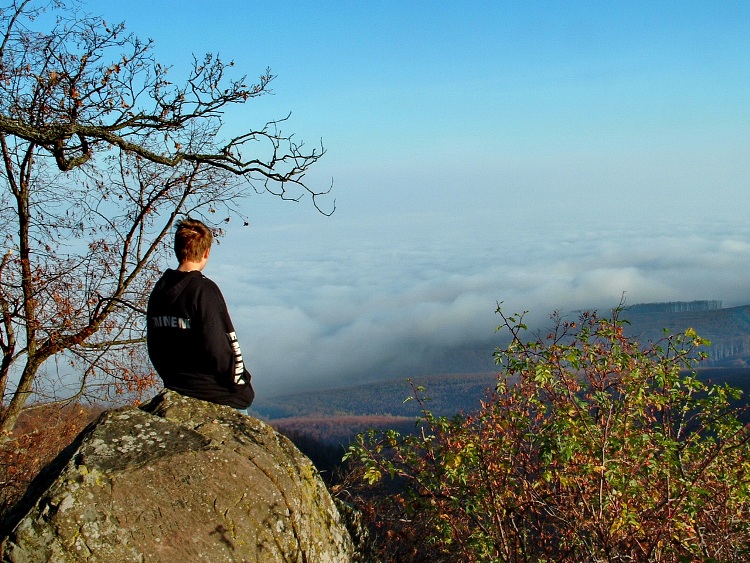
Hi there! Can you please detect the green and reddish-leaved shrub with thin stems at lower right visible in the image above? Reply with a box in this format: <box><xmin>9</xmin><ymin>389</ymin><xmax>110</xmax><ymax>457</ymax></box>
<box><xmin>347</xmin><ymin>307</ymin><xmax>750</xmax><ymax>562</ymax></box>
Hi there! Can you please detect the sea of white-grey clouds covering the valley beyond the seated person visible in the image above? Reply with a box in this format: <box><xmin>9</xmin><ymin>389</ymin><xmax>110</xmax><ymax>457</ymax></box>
<box><xmin>210</xmin><ymin>210</ymin><xmax>750</xmax><ymax>396</ymax></box>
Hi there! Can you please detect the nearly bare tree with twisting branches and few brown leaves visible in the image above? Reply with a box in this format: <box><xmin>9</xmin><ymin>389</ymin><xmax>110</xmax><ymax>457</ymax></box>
<box><xmin>0</xmin><ymin>0</ymin><xmax>333</xmax><ymax>431</ymax></box>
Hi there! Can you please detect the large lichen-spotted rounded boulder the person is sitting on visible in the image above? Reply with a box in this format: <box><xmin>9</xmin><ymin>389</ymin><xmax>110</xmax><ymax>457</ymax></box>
<box><xmin>2</xmin><ymin>391</ymin><xmax>353</xmax><ymax>563</ymax></box>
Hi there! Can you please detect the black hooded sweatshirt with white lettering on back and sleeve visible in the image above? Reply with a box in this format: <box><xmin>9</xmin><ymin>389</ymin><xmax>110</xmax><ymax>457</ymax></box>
<box><xmin>146</xmin><ymin>270</ymin><xmax>255</xmax><ymax>409</ymax></box>
